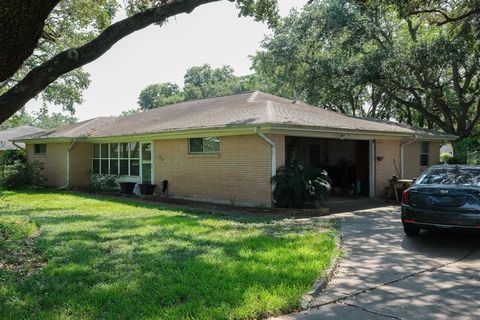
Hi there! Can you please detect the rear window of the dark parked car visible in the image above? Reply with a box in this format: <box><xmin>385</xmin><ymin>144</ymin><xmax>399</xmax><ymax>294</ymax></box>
<box><xmin>416</xmin><ymin>167</ymin><xmax>480</xmax><ymax>186</ymax></box>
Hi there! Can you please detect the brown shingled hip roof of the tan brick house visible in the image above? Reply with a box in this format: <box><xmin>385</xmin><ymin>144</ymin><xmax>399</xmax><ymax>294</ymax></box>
<box><xmin>15</xmin><ymin>91</ymin><xmax>454</xmax><ymax>139</ymax></box>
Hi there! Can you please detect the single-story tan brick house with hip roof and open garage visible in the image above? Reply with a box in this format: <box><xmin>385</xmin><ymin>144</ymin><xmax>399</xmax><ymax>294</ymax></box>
<box><xmin>15</xmin><ymin>91</ymin><xmax>456</xmax><ymax>206</ymax></box>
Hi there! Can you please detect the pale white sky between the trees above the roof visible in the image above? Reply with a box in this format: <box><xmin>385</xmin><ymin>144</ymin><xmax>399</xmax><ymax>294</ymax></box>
<box><xmin>27</xmin><ymin>0</ymin><xmax>308</xmax><ymax>120</ymax></box>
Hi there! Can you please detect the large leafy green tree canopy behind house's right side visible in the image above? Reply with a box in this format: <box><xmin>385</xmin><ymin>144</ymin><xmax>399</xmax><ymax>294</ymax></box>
<box><xmin>253</xmin><ymin>0</ymin><xmax>480</xmax><ymax>137</ymax></box>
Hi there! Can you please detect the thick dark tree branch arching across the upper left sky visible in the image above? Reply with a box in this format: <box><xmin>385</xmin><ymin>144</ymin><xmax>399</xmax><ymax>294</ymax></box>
<box><xmin>0</xmin><ymin>0</ymin><xmax>220</xmax><ymax>123</ymax></box>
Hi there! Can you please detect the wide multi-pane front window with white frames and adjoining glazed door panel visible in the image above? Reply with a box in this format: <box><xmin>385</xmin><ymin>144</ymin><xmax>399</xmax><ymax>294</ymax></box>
<box><xmin>92</xmin><ymin>142</ymin><xmax>152</xmax><ymax>181</ymax></box>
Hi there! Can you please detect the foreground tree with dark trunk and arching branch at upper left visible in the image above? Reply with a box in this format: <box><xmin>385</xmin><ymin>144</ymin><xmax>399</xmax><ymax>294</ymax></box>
<box><xmin>0</xmin><ymin>0</ymin><xmax>278</xmax><ymax>123</ymax></box>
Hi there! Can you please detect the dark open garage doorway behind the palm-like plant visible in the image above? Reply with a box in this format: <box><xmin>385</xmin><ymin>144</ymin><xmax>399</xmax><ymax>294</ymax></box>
<box><xmin>285</xmin><ymin>136</ymin><xmax>371</xmax><ymax>196</ymax></box>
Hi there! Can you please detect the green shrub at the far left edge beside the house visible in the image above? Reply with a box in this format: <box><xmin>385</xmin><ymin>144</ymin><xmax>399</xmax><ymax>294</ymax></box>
<box><xmin>0</xmin><ymin>160</ymin><xmax>44</xmax><ymax>189</ymax></box>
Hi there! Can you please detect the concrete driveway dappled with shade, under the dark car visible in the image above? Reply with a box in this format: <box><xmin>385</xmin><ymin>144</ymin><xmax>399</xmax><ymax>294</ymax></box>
<box><xmin>277</xmin><ymin>207</ymin><xmax>480</xmax><ymax>319</ymax></box>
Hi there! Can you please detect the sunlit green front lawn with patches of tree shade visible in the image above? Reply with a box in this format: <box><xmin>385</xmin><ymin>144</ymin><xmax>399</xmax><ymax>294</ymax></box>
<box><xmin>0</xmin><ymin>191</ymin><xmax>338</xmax><ymax>319</ymax></box>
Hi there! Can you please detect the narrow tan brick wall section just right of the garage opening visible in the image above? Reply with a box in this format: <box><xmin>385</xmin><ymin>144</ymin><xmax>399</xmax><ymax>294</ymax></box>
<box><xmin>375</xmin><ymin>140</ymin><xmax>400</xmax><ymax>197</ymax></box>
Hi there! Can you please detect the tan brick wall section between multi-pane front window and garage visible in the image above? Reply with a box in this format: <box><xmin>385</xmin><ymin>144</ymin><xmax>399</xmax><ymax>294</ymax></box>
<box><xmin>154</xmin><ymin>135</ymin><xmax>285</xmax><ymax>206</ymax></box>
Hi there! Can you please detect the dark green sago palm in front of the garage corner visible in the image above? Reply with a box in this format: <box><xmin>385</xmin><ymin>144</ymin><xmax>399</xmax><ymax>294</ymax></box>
<box><xmin>272</xmin><ymin>160</ymin><xmax>330</xmax><ymax>209</ymax></box>
